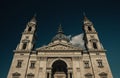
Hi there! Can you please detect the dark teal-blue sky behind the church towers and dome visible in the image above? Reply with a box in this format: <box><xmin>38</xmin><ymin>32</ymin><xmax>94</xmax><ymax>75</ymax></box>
<box><xmin>0</xmin><ymin>0</ymin><xmax>120</xmax><ymax>78</ymax></box>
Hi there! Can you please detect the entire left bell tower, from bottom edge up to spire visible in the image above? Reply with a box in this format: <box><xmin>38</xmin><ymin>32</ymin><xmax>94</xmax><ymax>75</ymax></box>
<box><xmin>7</xmin><ymin>15</ymin><xmax>36</xmax><ymax>78</ymax></box>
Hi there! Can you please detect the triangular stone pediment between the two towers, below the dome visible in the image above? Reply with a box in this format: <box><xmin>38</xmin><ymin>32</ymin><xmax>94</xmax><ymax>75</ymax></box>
<box><xmin>37</xmin><ymin>43</ymin><xmax>82</xmax><ymax>50</ymax></box>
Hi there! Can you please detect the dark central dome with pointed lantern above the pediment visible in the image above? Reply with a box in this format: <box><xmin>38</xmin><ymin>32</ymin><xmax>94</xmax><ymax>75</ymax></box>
<box><xmin>52</xmin><ymin>25</ymin><xmax>70</xmax><ymax>42</ymax></box>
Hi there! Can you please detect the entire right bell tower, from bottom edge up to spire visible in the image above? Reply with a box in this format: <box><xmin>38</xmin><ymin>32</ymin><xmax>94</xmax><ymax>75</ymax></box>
<box><xmin>83</xmin><ymin>15</ymin><xmax>113</xmax><ymax>78</ymax></box>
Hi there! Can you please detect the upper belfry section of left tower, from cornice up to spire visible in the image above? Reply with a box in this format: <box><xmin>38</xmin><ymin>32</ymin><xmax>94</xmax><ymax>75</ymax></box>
<box><xmin>16</xmin><ymin>15</ymin><xmax>36</xmax><ymax>51</ymax></box>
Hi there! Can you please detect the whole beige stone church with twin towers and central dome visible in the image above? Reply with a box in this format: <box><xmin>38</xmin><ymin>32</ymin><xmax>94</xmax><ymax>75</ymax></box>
<box><xmin>7</xmin><ymin>16</ymin><xmax>113</xmax><ymax>78</ymax></box>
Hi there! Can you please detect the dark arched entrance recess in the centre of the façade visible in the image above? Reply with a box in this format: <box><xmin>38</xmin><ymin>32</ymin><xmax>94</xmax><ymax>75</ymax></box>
<box><xmin>52</xmin><ymin>60</ymin><xmax>68</xmax><ymax>78</ymax></box>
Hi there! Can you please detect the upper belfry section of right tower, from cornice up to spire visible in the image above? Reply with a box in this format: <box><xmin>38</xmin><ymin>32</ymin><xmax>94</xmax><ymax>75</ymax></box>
<box><xmin>83</xmin><ymin>15</ymin><xmax>103</xmax><ymax>50</ymax></box>
